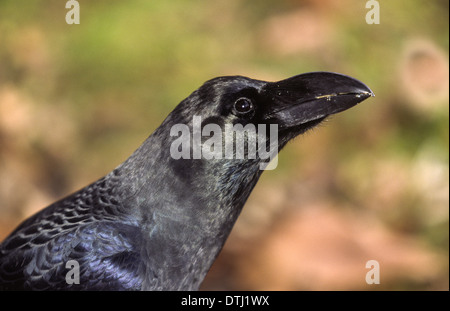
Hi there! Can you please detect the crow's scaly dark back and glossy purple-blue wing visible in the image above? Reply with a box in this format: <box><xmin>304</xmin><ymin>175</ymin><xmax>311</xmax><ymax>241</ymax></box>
<box><xmin>0</xmin><ymin>180</ymin><xmax>142</xmax><ymax>289</ymax></box>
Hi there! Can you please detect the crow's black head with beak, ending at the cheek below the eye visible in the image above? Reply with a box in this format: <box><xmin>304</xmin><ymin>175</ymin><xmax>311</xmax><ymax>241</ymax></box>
<box><xmin>166</xmin><ymin>72</ymin><xmax>373</xmax><ymax>169</ymax></box>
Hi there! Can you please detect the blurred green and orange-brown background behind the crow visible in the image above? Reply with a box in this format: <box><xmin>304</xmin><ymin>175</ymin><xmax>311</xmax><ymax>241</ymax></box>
<box><xmin>0</xmin><ymin>0</ymin><xmax>449</xmax><ymax>290</ymax></box>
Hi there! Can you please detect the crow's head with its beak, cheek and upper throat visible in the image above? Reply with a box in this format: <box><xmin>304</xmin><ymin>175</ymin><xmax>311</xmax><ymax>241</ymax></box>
<box><xmin>142</xmin><ymin>72</ymin><xmax>373</xmax><ymax>210</ymax></box>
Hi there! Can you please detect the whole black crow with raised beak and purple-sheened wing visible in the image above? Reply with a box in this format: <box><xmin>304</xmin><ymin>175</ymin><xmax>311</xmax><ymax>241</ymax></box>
<box><xmin>0</xmin><ymin>72</ymin><xmax>374</xmax><ymax>290</ymax></box>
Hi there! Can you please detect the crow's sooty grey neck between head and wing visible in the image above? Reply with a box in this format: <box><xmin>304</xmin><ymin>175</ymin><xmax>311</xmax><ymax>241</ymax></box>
<box><xmin>117</xmin><ymin>132</ymin><xmax>262</xmax><ymax>289</ymax></box>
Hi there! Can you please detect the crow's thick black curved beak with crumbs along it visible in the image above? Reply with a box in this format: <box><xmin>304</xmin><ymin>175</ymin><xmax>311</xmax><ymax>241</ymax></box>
<box><xmin>263</xmin><ymin>72</ymin><xmax>375</xmax><ymax>129</ymax></box>
